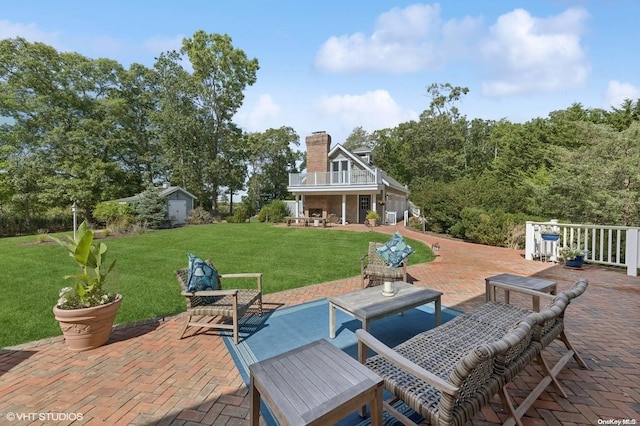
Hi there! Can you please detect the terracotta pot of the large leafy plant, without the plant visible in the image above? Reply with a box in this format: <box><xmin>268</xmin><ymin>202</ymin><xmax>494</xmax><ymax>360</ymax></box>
<box><xmin>53</xmin><ymin>294</ymin><xmax>122</xmax><ymax>351</ymax></box>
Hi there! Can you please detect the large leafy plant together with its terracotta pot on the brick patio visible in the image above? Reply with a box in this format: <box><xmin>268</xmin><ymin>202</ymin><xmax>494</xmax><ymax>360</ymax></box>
<box><xmin>51</xmin><ymin>222</ymin><xmax>122</xmax><ymax>351</ymax></box>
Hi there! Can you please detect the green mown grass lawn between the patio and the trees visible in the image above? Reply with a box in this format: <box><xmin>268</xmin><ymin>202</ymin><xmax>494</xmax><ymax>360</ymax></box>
<box><xmin>0</xmin><ymin>223</ymin><xmax>434</xmax><ymax>347</ymax></box>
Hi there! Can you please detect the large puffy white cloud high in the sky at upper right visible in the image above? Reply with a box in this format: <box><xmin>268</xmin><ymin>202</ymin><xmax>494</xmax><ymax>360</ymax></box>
<box><xmin>480</xmin><ymin>8</ymin><xmax>590</xmax><ymax>96</ymax></box>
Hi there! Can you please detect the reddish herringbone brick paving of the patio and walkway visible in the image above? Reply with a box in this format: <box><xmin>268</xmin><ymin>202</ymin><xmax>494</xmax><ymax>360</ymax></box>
<box><xmin>0</xmin><ymin>225</ymin><xmax>640</xmax><ymax>425</ymax></box>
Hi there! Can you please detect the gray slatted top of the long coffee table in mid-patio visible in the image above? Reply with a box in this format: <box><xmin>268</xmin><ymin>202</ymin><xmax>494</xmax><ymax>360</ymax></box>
<box><xmin>329</xmin><ymin>281</ymin><xmax>442</xmax><ymax>320</ymax></box>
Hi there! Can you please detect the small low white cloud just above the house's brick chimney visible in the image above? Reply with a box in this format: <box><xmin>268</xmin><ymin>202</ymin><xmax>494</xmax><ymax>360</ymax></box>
<box><xmin>314</xmin><ymin>90</ymin><xmax>418</xmax><ymax>132</ymax></box>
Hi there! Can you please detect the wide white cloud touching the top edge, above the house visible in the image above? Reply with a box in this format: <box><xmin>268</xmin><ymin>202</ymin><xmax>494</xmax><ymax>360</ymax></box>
<box><xmin>315</xmin><ymin>3</ymin><xmax>480</xmax><ymax>73</ymax></box>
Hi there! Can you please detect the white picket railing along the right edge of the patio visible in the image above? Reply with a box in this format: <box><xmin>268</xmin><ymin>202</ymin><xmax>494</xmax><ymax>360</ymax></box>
<box><xmin>525</xmin><ymin>221</ymin><xmax>640</xmax><ymax>277</ymax></box>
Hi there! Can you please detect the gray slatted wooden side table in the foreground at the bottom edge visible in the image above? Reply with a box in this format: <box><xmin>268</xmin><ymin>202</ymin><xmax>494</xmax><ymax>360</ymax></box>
<box><xmin>249</xmin><ymin>339</ymin><xmax>383</xmax><ymax>426</ymax></box>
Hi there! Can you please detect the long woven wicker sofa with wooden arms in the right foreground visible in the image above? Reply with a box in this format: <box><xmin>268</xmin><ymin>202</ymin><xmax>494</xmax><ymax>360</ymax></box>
<box><xmin>356</xmin><ymin>279</ymin><xmax>588</xmax><ymax>425</ymax></box>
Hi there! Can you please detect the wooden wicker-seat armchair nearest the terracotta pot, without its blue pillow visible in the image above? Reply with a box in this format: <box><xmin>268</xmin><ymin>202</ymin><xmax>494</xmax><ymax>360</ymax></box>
<box><xmin>175</xmin><ymin>260</ymin><xmax>262</xmax><ymax>345</ymax></box>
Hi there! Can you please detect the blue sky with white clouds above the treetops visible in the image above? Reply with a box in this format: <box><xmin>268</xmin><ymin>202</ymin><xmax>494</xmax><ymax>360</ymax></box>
<box><xmin>0</xmin><ymin>0</ymin><xmax>640</xmax><ymax>148</ymax></box>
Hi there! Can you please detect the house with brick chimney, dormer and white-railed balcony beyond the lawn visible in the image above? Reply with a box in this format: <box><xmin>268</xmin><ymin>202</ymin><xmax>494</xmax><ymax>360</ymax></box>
<box><xmin>287</xmin><ymin>132</ymin><xmax>409</xmax><ymax>224</ymax></box>
